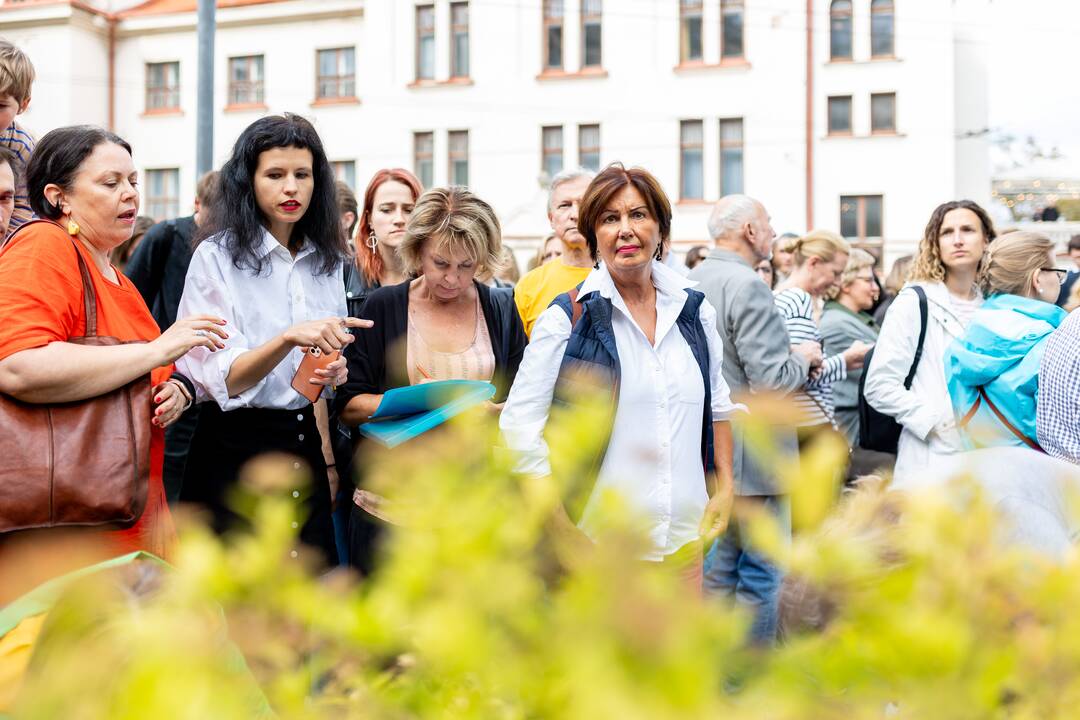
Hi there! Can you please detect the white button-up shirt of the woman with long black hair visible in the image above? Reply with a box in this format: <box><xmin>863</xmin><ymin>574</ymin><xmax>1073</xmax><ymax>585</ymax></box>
<box><xmin>176</xmin><ymin>231</ymin><xmax>348</xmax><ymax>410</ymax></box>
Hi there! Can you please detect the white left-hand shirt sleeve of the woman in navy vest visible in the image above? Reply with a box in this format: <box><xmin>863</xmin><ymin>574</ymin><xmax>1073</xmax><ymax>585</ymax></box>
<box><xmin>499</xmin><ymin>307</ymin><xmax>570</xmax><ymax>477</ymax></box>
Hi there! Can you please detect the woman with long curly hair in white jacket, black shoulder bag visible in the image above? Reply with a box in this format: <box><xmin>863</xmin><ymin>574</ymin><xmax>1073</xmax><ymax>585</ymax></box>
<box><xmin>863</xmin><ymin>200</ymin><xmax>996</xmax><ymax>487</ymax></box>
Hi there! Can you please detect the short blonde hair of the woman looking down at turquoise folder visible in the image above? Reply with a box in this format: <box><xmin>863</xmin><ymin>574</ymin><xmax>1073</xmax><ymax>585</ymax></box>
<box><xmin>397</xmin><ymin>186</ymin><xmax>502</xmax><ymax>275</ymax></box>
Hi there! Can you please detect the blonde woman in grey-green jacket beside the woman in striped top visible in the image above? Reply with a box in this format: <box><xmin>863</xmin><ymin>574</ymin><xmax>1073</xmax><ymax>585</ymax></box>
<box><xmin>821</xmin><ymin>248</ymin><xmax>879</xmax><ymax>447</ymax></box>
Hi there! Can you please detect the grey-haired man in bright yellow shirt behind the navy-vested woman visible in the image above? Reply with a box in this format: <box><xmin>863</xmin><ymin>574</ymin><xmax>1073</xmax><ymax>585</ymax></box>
<box><xmin>514</xmin><ymin>169</ymin><xmax>595</xmax><ymax>335</ymax></box>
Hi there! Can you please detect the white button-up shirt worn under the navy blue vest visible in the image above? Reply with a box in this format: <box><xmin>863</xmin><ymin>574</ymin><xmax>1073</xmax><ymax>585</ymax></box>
<box><xmin>499</xmin><ymin>262</ymin><xmax>747</xmax><ymax>560</ymax></box>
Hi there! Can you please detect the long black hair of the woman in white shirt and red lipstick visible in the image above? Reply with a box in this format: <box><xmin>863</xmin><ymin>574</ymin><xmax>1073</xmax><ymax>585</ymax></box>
<box><xmin>195</xmin><ymin>112</ymin><xmax>349</xmax><ymax>275</ymax></box>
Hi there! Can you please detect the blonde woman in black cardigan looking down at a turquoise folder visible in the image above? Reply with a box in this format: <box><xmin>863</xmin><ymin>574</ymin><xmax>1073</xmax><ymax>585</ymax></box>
<box><xmin>335</xmin><ymin>187</ymin><xmax>527</xmax><ymax>573</ymax></box>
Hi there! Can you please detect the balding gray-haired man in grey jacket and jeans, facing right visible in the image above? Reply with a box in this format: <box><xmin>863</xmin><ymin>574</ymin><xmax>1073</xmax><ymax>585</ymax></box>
<box><xmin>690</xmin><ymin>195</ymin><xmax>821</xmax><ymax>643</ymax></box>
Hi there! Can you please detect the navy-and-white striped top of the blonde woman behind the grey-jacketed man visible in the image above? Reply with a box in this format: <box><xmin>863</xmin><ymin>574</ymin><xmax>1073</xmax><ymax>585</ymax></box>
<box><xmin>773</xmin><ymin>287</ymin><xmax>848</xmax><ymax>427</ymax></box>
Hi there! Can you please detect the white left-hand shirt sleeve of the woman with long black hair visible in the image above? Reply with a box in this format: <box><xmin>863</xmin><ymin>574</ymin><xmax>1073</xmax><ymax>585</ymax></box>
<box><xmin>176</xmin><ymin>242</ymin><xmax>266</xmax><ymax>410</ymax></box>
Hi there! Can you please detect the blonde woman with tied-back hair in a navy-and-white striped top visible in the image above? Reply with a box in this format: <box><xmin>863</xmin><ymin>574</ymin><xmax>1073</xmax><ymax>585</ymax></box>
<box><xmin>773</xmin><ymin>230</ymin><xmax>870</xmax><ymax>443</ymax></box>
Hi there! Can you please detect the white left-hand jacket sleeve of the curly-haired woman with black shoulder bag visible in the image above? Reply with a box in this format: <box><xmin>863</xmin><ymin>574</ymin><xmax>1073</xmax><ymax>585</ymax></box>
<box><xmin>865</xmin><ymin>291</ymin><xmax>939</xmax><ymax>440</ymax></box>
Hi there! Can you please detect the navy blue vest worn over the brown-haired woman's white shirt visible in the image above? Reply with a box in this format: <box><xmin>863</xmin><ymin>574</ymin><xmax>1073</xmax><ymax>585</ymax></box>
<box><xmin>551</xmin><ymin>285</ymin><xmax>714</xmax><ymax>522</ymax></box>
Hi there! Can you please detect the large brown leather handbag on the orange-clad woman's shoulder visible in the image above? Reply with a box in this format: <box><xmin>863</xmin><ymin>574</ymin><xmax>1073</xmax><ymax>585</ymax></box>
<box><xmin>0</xmin><ymin>223</ymin><xmax>151</xmax><ymax>532</ymax></box>
